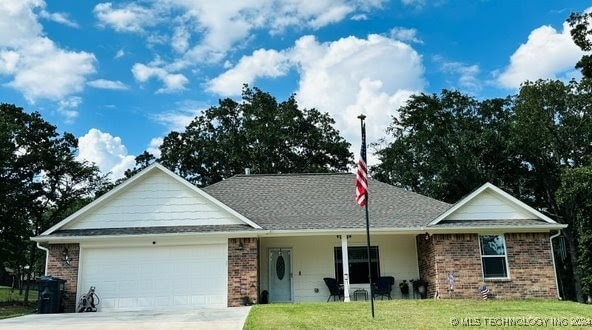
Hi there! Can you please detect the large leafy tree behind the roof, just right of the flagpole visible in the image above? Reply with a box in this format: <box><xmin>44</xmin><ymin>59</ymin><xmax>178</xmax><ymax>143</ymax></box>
<box><xmin>372</xmin><ymin>90</ymin><xmax>521</xmax><ymax>202</ymax></box>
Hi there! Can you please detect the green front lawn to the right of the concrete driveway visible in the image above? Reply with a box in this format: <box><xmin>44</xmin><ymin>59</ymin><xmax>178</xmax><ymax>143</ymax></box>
<box><xmin>245</xmin><ymin>299</ymin><xmax>592</xmax><ymax>329</ymax></box>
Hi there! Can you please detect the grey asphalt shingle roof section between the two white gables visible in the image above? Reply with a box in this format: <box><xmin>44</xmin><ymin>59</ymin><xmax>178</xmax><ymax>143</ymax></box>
<box><xmin>204</xmin><ymin>173</ymin><xmax>451</xmax><ymax>230</ymax></box>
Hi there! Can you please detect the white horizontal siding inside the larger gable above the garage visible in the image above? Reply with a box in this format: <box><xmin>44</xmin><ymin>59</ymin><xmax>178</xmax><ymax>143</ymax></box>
<box><xmin>65</xmin><ymin>171</ymin><xmax>243</xmax><ymax>229</ymax></box>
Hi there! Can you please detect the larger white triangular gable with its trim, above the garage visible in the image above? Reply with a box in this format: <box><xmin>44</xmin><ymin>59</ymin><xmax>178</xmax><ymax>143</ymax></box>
<box><xmin>42</xmin><ymin>163</ymin><xmax>261</xmax><ymax>235</ymax></box>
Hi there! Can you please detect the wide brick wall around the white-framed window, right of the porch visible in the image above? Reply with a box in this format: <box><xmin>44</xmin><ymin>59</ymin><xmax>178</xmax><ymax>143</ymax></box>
<box><xmin>416</xmin><ymin>233</ymin><xmax>556</xmax><ymax>299</ymax></box>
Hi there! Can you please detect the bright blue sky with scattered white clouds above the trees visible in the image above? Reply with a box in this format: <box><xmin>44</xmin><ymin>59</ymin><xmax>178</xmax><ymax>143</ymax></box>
<box><xmin>0</xmin><ymin>0</ymin><xmax>592</xmax><ymax>179</ymax></box>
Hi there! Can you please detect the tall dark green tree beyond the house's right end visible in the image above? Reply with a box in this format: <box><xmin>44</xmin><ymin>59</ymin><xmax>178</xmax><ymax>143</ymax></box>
<box><xmin>512</xmin><ymin>79</ymin><xmax>592</xmax><ymax>301</ymax></box>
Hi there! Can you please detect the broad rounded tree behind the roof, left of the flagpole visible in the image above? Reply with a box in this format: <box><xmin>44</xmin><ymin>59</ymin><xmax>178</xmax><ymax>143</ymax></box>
<box><xmin>160</xmin><ymin>85</ymin><xmax>353</xmax><ymax>186</ymax></box>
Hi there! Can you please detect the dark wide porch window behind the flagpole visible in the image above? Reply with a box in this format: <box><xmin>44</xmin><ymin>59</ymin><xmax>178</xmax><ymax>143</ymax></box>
<box><xmin>335</xmin><ymin>246</ymin><xmax>380</xmax><ymax>284</ymax></box>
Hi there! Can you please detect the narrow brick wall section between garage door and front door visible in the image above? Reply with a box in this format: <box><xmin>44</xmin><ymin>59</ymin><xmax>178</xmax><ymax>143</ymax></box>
<box><xmin>228</xmin><ymin>238</ymin><xmax>259</xmax><ymax>307</ymax></box>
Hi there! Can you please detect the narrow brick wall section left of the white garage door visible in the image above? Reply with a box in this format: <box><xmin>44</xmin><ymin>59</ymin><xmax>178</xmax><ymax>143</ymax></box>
<box><xmin>47</xmin><ymin>244</ymin><xmax>80</xmax><ymax>312</ymax></box>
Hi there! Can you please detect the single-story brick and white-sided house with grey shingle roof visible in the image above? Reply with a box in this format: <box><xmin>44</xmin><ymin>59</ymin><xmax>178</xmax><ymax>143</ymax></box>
<box><xmin>32</xmin><ymin>164</ymin><xmax>566</xmax><ymax>311</ymax></box>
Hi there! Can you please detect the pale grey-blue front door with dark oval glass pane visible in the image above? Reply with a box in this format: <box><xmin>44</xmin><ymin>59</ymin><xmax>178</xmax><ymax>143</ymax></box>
<box><xmin>269</xmin><ymin>249</ymin><xmax>292</xmax><ymax>302</ymax></box>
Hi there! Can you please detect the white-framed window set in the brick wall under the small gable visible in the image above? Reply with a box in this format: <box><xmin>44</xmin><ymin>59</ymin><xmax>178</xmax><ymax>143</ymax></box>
<box><xmin>479</xmin><ymin>235</ymin><xmax>508</xmax><ymax>278</ymax></box>
